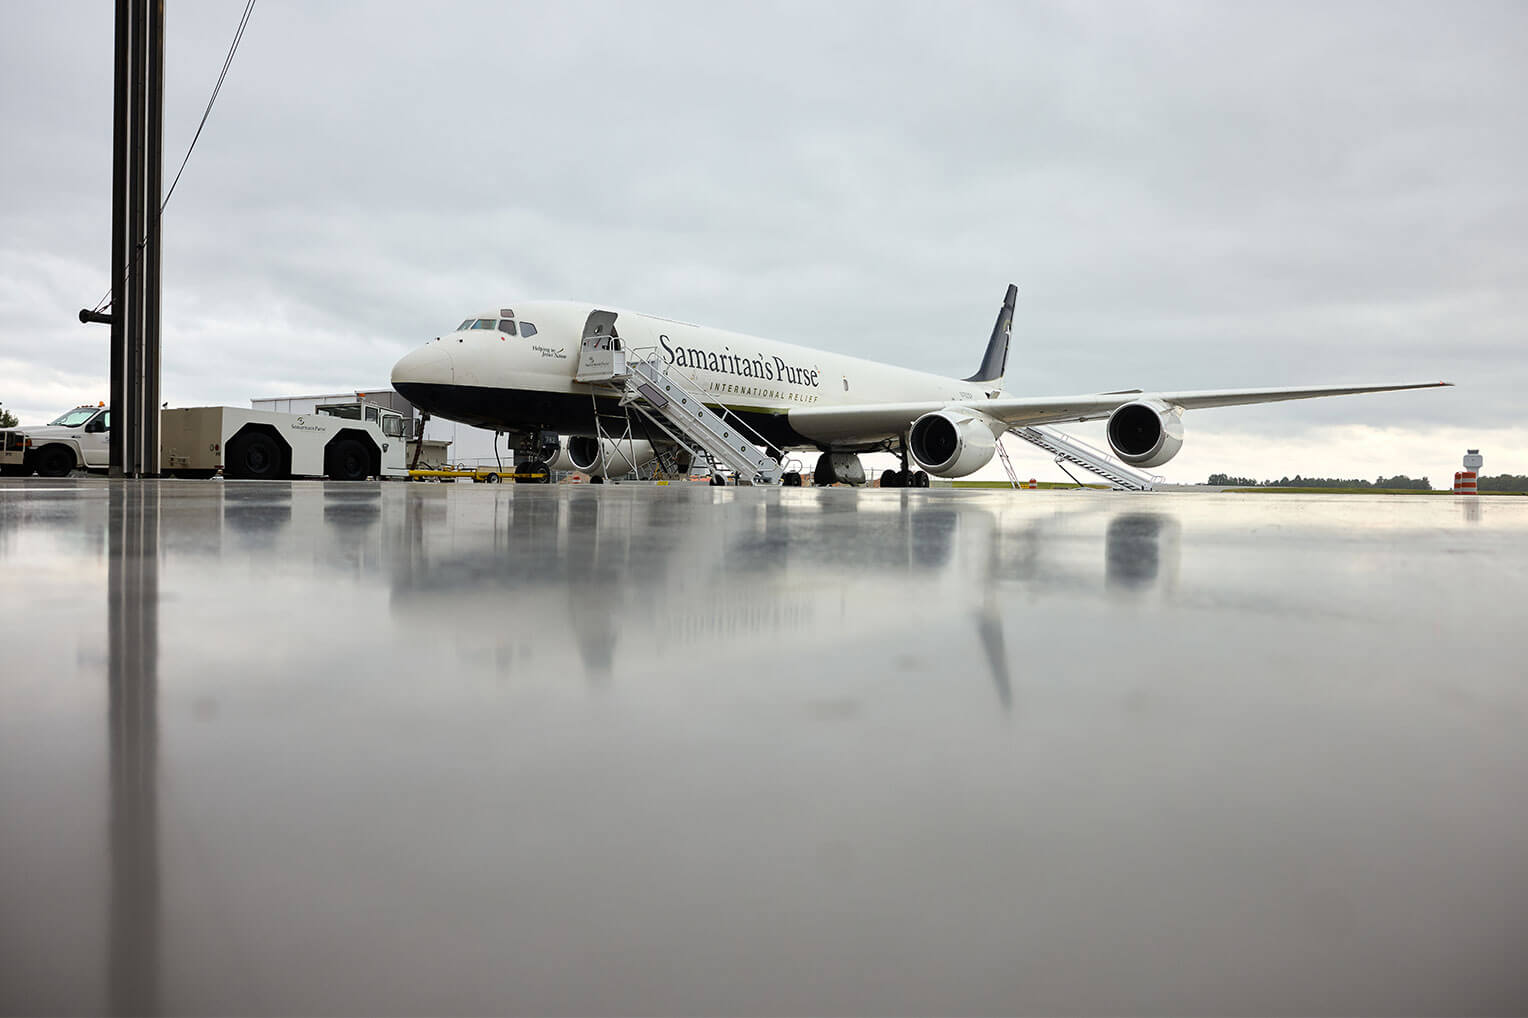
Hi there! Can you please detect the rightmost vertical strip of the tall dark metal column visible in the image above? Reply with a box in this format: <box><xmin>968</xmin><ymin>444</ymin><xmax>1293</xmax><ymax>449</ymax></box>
<box><xmin>141</xmin><ymin>0</ymin><xmax>165</xmax><ymax>477</ymax></box>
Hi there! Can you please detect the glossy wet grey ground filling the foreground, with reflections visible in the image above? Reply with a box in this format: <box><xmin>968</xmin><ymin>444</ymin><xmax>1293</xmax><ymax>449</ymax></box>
<box><xmin>0</xmin><ymin>478</ymin><xmax>1528</xmax><ymax>1015</ymax></box>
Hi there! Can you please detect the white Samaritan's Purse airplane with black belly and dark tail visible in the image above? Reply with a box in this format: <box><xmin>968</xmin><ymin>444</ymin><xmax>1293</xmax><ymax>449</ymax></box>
<box><xmin>393</xmin><ymin>286</ymin><xmax>1449</xmax><ymax>488</ymax></box>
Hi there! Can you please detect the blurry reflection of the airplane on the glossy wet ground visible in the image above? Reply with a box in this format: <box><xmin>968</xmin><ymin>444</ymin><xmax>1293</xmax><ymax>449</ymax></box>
<box><xmin>382</xmin><ymin>488</ymin><xmax>1178</xmax><ymax>706</ymax></box>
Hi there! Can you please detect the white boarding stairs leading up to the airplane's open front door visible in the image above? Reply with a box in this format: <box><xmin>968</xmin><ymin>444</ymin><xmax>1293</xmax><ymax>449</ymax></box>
<box><xmin>578</xmin><ymin>336</ymin><xmax>784</xmax><ymax>485</ymax></box>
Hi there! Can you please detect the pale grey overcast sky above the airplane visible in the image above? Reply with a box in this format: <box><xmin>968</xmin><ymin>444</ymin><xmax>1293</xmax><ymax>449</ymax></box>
<box><xmin>0</xmin><ymin>0</ymin><xmax>1528</xmax><ymax>483</ymax></box>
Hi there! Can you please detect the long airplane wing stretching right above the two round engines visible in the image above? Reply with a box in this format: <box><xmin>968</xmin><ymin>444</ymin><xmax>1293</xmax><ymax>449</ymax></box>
<box><xmin>788</xmin><ymin>382</ymin><xmax>1452</xmax><ymax>443</ymax></box>
